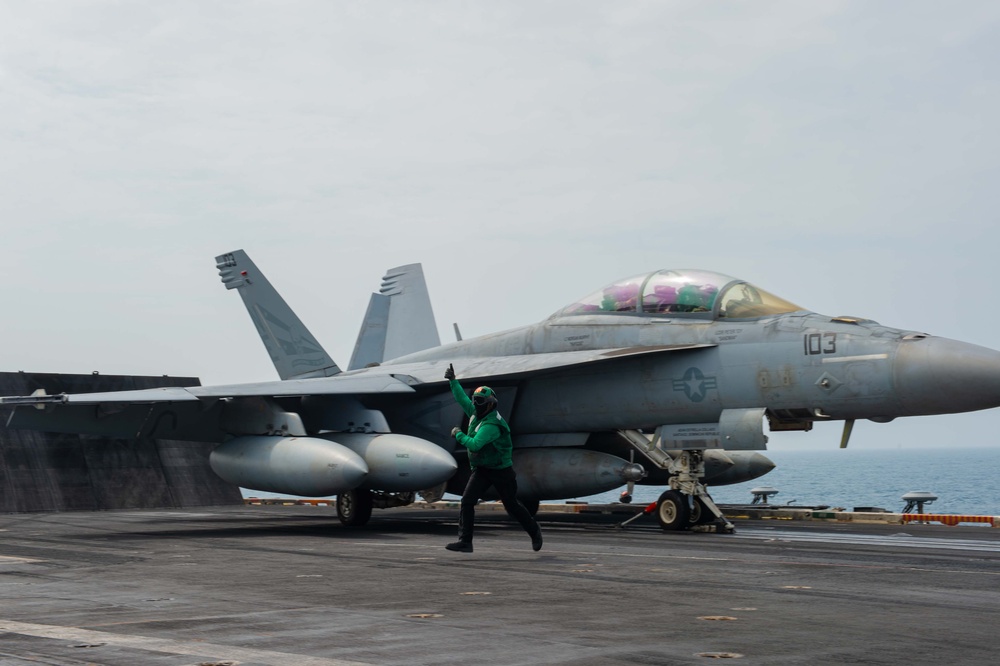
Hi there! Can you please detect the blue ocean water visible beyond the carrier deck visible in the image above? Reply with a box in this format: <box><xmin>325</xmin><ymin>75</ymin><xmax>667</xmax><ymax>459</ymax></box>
<box><xmin>243</xmin><ymin>448</ymin><xmax>1000</xmax><ymax>516</ymax></box>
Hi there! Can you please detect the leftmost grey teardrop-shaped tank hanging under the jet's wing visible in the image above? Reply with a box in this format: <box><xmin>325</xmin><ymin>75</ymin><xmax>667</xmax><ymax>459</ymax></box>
<box><xmin>208</xmin><ymin>435</ymin><xmax>368</xmax><ymax>497</ymax></box>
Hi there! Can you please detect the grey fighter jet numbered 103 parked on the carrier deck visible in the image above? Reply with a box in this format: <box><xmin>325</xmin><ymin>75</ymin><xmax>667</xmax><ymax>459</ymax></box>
<box><xmin>0</xmin><ymin>250</ymin><xmax>1000</xmax><ymax>531</ymax></box>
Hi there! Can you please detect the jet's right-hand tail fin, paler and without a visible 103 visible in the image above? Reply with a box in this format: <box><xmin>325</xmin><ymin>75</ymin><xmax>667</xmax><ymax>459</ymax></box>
<box><xmin>348</xmin><ymin>264</ymin><xmax>441</xmax><ymax>370</ymax></box>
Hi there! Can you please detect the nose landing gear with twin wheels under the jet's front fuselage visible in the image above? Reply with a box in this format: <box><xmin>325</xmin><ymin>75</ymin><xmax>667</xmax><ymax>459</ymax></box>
<box><xmin>656</xmin><ymin>450</ymin><xmax>735</xmax><ymax>534</ymax></box>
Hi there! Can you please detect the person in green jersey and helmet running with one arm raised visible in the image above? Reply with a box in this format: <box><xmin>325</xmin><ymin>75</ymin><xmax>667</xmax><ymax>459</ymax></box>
<box><xmin>444</xmin><ymin>364</ymin><xmax>542</xmax><ymax>553</ymax></box>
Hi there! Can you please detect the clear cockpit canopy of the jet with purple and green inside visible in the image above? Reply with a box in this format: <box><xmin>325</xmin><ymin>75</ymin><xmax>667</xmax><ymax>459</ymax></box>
<box><xmin>553</xmin><ymin>269</ymin><xmax>802</xmax><ymax>319</ymax></box>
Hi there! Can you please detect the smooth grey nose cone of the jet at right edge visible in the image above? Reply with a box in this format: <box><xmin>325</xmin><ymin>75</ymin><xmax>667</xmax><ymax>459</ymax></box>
<box><xmin>893</xmin><ymin>337</ymin><xmax>1000</xmax><ymax>415</ymax></box>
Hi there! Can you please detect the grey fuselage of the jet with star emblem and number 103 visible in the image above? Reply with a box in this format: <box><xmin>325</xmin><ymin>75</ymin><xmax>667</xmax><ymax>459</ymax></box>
<box><xmin>380</xmin><ymin>304</ymin><xmax>1000</xmax><ymax>433</ymax></box>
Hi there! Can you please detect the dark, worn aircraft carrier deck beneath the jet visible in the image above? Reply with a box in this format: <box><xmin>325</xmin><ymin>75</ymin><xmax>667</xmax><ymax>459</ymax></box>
<box><xmin>0</xmin><ymin>505</ymin><xmax>1000</xmax><ymax>666</ymax></box>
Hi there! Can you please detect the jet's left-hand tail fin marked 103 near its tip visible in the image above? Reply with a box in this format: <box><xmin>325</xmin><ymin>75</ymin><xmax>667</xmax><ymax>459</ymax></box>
<box><xmin>215</xmin><ymin>250</ymin><xmax>340</xmax><ymax>379</ymax></box>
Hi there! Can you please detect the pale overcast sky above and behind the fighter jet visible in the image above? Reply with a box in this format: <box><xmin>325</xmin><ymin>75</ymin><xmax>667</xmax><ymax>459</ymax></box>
<box><xmin>0</xmin><ymin>0</ymin><xmax>1000</xmax><ymax>448</ymax></box>
